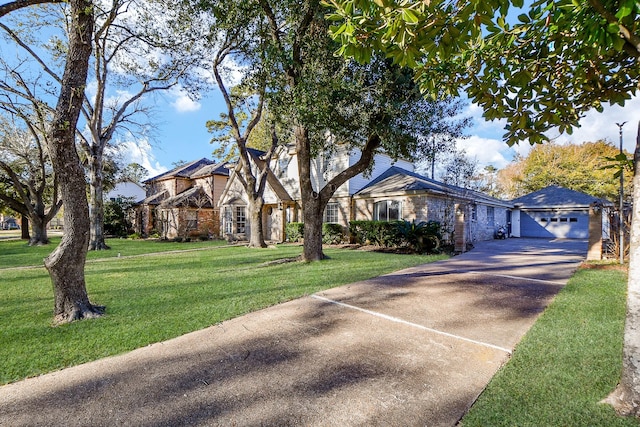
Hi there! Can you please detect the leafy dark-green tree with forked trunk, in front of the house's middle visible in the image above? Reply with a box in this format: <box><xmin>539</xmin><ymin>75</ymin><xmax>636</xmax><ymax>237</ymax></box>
<box><xmin>259</xmin><ymin>0</ymin><xmax>470</xmax><ymax>261</ymax></box>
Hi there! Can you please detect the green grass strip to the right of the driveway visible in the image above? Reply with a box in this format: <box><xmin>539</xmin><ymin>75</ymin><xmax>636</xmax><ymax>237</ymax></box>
<box><xmin>462</xmin><ymin>269</ymin><xmax>640</xmax><ymax>427</ymax></box>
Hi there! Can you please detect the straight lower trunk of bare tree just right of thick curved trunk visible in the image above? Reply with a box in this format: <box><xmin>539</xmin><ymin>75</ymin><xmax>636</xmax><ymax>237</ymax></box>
<box><xmin>89</xmin><ymin>153</ymin><xmax>111</xmax><ymax>251</ymax></box>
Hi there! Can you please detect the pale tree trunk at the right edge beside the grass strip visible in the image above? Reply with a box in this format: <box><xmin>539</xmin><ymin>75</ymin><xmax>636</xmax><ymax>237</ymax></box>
<box><xmin>605</xmin><ymin>123</ymin><xmax>640</xmax><ymax>417</ymax></box>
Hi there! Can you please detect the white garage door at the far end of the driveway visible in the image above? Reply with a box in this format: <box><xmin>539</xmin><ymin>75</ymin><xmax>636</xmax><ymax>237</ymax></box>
<box><xmin>520</xmin><ymin>211</ymin><xmax>589</xmax><ymax>239</ymax></box>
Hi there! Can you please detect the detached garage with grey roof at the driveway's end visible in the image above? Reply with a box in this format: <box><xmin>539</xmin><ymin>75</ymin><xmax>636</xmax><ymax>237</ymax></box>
<box><xmin>512</xmin><ymin>185</ymin><xmax>612</xmax><ymax>239</ymax></box>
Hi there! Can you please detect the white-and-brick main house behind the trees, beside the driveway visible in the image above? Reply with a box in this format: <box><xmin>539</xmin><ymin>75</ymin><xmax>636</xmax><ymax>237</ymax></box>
<box><xmin>219</xmin><ymin>146</ymin><xmax>512</xmax><ymax>250</ymax></box>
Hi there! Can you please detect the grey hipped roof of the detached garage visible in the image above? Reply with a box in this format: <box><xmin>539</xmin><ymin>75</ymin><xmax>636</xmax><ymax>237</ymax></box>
<box><xmin>511</xmin><ymin>185</ymin><xmax>612</xmax><ymax>209</ymax></box>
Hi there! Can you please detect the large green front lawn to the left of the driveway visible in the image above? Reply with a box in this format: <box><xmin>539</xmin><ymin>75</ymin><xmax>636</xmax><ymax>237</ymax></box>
<box><xmin>0</xmin><ymin>241</ymin><xmax>444</xmax><ymax>384</ymax></box>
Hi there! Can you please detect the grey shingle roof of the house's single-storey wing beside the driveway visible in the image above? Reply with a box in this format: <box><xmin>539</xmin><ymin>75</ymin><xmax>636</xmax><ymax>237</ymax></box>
<box><xmin>355</xmin><ymin>166</ymin><xmax>512</xmax><ymax>207</ymax></box>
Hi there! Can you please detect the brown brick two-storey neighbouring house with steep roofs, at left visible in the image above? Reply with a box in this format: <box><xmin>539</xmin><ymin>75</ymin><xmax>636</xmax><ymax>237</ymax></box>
<box><xmin>135</xmin><ymin>158</ymin><xmax>229</xmax><ymax>238</ymax></box>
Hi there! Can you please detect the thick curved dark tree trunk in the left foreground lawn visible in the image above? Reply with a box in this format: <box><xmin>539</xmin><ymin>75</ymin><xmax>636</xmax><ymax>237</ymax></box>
<box><xmin>45</xmin><ymin>0</ymin><xmax>104</xmax><ymax>324</ymax></box>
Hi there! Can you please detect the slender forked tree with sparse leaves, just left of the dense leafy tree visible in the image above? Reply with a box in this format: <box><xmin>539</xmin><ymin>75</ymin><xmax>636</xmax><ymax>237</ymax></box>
<box><xmin>202</xmin><ymin>1</ymin><xmax>278</xmax><ymax>248</ymax></box>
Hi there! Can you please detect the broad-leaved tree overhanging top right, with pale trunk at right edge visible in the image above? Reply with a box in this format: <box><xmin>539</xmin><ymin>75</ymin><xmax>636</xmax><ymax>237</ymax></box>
<box><xmin>327</xmin><ymin>0</ymin><xmax>640</xmax><ymax>416</ymax></box>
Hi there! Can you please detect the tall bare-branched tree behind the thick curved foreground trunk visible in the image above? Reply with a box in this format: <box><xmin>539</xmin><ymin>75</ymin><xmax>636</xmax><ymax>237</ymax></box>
<box><xmin>0</xmin><ymin>0</ymin><xmax>201</xmax><ymax>250</ymax></box>
